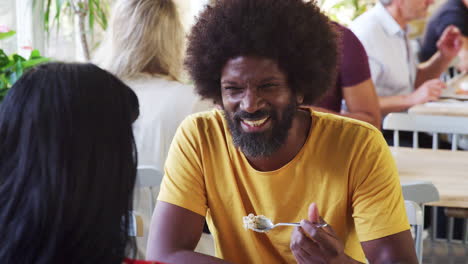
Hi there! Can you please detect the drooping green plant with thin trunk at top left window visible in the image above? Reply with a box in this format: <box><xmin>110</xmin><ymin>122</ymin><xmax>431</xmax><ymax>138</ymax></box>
<box><xmin>34</xmin><ymin>0</ymin><xmax>110</xmax><ymax>60</ymax></box>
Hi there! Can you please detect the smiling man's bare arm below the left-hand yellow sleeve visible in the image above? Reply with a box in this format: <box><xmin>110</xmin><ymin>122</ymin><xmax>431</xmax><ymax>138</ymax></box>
<box><xmin>146</xmin><ymin>201</ymin><xmax>227</xmax><ymax>264</ymax></box>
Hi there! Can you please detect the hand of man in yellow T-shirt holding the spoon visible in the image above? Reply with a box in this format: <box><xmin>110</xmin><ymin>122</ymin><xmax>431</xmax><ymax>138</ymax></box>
<box><xmin>290</xmin><ymin>203</ymin><xmax>353</xmax><ymax>264</ymax></box>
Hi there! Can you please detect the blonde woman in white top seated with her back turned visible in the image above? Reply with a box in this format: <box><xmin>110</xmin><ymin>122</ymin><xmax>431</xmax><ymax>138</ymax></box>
<box><xmin>96</xmin><ymin>0</ymin><xmax>211</xmax><ymax>257</ymax></box>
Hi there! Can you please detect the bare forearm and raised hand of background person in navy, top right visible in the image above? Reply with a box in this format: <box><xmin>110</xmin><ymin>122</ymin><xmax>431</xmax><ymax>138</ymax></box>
<box><xmin>415</xmin><ymin>26</ymin><xmax>463</xmax><ymax>87</ymax></box>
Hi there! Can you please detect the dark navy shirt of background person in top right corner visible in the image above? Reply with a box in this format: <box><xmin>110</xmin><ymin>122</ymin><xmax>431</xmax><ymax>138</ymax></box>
<box><xmin>419</xmin><ymin>0</ymin><xmax>468</xmax><ymax>71</ymax></box>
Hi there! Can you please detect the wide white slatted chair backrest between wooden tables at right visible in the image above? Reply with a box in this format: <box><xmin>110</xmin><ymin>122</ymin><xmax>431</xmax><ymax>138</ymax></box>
<box><xmin>383</xmin><ymin>113</ymin><xmax>468</xmax><ymax>150</ymax></box>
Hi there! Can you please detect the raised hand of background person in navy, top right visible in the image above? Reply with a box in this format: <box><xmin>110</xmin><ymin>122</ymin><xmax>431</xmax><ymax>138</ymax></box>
<box><xmin>437</xmin><ymin>25</ymin><xmax>463</xmax><ymax>60</ymax></box>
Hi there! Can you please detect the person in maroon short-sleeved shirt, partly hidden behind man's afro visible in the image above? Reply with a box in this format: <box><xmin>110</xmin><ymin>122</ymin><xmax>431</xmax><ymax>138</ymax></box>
<box><xmin>314</xmin><ymin>23</ymin><xmax>381</xmax><ymax>128</ymax></box>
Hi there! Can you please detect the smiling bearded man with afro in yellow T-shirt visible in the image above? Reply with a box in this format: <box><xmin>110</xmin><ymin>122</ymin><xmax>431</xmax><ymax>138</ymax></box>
<box><xmin>147</xmin><ymin>0</ymin><xmax>416</xmax><ymax>263</ymax></box>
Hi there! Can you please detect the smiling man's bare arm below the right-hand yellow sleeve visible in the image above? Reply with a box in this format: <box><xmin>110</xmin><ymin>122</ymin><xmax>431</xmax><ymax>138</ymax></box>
<box><xmin>361</xmin><ymin>230</ymin><xmax>418</xmax><ymax>264</ymax></box>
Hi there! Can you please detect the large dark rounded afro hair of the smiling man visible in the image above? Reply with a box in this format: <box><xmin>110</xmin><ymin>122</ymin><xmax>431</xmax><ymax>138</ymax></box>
<box><xmin>185</xmin><ymin>0</ymin><xmax>337</xmax><ymax>104</ymax></box>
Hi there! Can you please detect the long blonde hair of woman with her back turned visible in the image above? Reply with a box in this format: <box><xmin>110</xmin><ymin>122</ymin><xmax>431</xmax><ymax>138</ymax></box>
<box><xmin>97</xmin><ymin>0</ymin><xmax>185</xmax><ymax>80</ymax></box>
